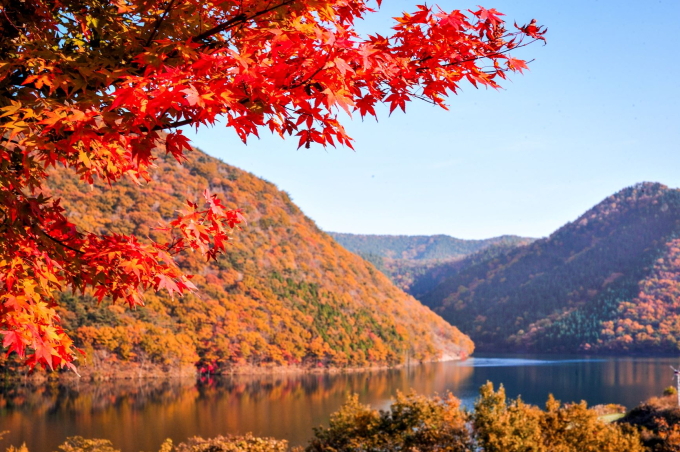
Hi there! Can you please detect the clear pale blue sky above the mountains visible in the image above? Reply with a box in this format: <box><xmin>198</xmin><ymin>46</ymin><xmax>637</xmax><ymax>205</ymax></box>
<box><xmin>187</xmin><ymin>0</ymin><xmax>680</xmax><ymax>239</ymax></box>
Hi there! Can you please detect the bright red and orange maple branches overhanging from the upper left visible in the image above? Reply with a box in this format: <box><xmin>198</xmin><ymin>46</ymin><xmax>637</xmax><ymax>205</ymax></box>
<box><xmin>0</xmin><ymin>0</ymin><xmax>544</xmax><ymax>368</ymax></box>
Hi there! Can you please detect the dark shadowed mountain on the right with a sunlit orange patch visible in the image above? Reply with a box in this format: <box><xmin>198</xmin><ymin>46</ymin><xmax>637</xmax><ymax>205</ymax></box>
<box><xmin>420</xmin><ymin>183</ymin><xmax>680</xmax><ymax>353</ymax></box>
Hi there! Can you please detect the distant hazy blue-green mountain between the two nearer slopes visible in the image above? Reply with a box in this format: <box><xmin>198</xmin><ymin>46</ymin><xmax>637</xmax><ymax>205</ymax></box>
<box><xmin>329</xmin><ymin>232</ymin><xmax>534</xmax><ymax>297</ymax></box>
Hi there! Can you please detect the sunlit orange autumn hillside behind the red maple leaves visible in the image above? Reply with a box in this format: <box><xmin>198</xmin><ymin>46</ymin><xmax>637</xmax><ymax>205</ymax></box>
<box><xmin>2</xmin><ymin>150</ymin><xmax>473</xmax><ymax>369</ymax></box>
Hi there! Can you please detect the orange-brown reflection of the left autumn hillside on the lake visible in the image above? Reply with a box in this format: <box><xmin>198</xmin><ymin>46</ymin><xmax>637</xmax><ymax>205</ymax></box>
<box><xmin>0</xmin><ymin>363</ymin><xmax>473</xmax><ymax>451</ymax></box>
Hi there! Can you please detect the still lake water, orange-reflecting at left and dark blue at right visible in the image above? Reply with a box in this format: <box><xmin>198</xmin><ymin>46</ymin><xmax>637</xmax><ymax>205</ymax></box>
<box><xmin>0</xmin><ymin>355</ymin><xmax>680</xmax><ymax>452</ymax></box>
